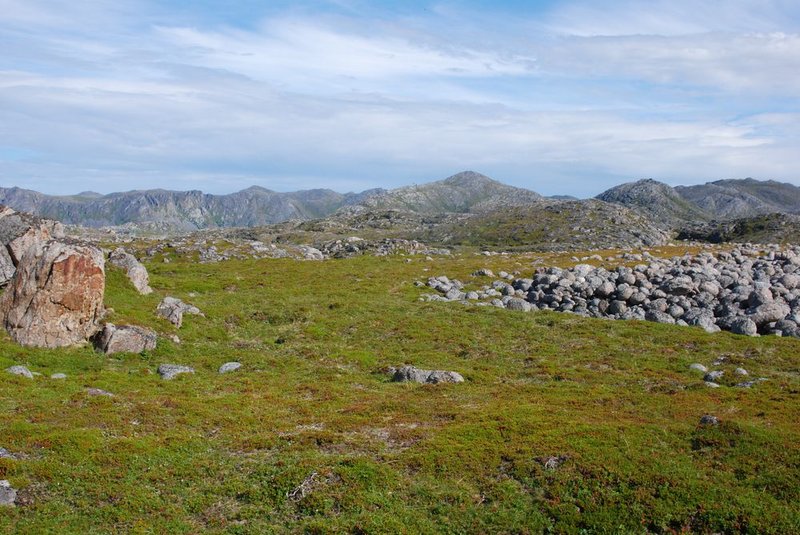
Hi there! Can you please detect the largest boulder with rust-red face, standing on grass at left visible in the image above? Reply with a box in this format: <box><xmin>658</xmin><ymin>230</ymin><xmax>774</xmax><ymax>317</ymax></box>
<box><xmin>0</xmin><ymin>240</ymin><xmax>105</xmax><ymax>347</ymax></box>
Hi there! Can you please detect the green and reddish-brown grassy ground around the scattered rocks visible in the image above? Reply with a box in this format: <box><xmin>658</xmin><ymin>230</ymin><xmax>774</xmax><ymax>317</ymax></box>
<box><xmin>0</xmin><ymin>249</ymin><xmax>800</xmax><ymax>533</ymax></box>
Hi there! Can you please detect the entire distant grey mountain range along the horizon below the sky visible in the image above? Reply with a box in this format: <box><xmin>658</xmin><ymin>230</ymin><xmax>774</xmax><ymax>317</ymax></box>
<box><xmin>0</xmin><ymin>171</ymin><xmax>800</xmax><ymax>231</ymax></box>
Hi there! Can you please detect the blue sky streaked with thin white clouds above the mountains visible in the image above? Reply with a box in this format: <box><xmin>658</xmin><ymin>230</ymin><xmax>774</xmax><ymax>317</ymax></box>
<box><xmin>0</xmin><ymin>0</ymin><xmax>800</xmax><ymax>197</ymax></box>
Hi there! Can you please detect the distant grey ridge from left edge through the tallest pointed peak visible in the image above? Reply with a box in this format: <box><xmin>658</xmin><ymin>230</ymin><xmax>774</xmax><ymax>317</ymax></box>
<box><xmin>0</xmin><ymin>171</ymin><xmax>542</xmax><ymax>231</ymax></box>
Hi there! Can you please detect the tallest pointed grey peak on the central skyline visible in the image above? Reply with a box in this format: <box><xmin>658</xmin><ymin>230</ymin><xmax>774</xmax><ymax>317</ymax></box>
<box><xmin>338</xmin><ymin>171</ymin><xmax>542</xmax><ymax>214</ymax></box>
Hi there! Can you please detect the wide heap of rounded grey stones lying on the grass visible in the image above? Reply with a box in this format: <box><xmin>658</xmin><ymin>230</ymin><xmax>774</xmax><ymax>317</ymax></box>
<box><xmin>418</xmin><ymin>247</ymin><xmax>800</xmax><ymax>337</ymax></box>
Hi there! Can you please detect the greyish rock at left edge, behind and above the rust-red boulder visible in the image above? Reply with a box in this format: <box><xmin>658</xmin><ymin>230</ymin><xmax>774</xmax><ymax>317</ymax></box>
<box><xmin>0</xmin><ymin>206</ymin><xmax>64</xmax><ymax>286</ymax></box>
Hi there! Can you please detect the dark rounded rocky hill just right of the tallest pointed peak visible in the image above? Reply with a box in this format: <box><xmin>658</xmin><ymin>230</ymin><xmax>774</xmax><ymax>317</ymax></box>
<box><xmin>597</xmin><ymin>178</ymin><xmax>710</xmax><ymax>228</ymax></box>
